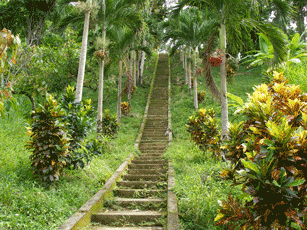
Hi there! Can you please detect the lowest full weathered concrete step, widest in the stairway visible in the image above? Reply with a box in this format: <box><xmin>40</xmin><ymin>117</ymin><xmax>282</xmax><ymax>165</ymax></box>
<box><xmin>92</xmin><ymin>211</ymin><xmax>163</xmax><ymax>226</ymax></box>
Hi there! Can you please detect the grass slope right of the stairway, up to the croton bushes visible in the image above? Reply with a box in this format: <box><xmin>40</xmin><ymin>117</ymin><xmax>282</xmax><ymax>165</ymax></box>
<box><xmin>166</xmin><ymin>52</ymin><xmax>262</xmax><ymax>230</ymax></box>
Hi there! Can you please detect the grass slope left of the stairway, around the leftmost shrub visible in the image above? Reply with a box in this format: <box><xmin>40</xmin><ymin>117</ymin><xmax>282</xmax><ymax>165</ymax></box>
<box><xmin>0</xmin><ymin>53</ymin><xmax>157</xmax><ymax>230</ymax></box>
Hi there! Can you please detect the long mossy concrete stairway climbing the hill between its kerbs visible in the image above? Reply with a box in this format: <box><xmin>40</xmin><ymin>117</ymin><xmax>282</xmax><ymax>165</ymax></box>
<box><xmin>91</xmin><ymin>54</ymin><xmax>169</xmax><ymax>230</ymax></box>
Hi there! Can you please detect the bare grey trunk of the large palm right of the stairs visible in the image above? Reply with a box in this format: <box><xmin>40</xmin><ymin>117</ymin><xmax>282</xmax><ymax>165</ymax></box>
<box><xmin>220</xmin><ymin>23</ymin><xmax>228</xmax><ymax>139</ymax></box>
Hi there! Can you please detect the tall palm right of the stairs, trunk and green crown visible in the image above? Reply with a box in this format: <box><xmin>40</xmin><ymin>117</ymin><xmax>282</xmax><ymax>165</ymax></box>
<box><xmin>177</xmin><ymin>0</ymin><xmax>289</xmax><ymax>138</ymax></box>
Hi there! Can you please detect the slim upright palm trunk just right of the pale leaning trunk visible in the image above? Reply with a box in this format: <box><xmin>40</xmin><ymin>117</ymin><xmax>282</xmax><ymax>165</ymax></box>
<box><xmin>97</xmin><ymin>0</ymin><xmax>106</xmax><ymax>134</ymax></box>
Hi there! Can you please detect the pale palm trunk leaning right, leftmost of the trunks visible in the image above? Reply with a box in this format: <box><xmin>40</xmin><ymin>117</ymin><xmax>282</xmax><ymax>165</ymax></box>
<box><xmin>75</xmin><ymin>7</ymin><xmax>90</xmax><ymax>102</ymax></box>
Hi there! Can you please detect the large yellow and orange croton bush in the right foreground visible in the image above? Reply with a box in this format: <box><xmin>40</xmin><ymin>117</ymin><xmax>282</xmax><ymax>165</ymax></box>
<box><xmin>215</xmin><ymin>72</ymin><xmax>307</xmax><ymax>229</ymax></box>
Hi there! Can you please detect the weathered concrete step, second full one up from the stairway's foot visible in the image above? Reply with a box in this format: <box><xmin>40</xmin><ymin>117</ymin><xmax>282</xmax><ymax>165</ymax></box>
<box><xmin>114</xmin><ymin>188</ymin><xmax>166</xmax><ymax>198</ymax></box>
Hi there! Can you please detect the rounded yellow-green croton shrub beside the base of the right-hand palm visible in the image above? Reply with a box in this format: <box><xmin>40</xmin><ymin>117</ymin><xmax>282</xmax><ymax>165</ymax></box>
<box><xmin>187</xmin><ymin>109</ymin><xmax>221</xmax><ymax>156</ymax></box>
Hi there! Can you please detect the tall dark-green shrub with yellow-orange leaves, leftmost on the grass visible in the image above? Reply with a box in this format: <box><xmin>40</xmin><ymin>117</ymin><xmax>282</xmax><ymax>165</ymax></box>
<box><xmin>26</xmin><ymin>95</ymin><xmax>69</xmax><ymax>183</ymax></box>
